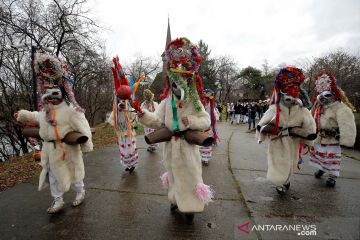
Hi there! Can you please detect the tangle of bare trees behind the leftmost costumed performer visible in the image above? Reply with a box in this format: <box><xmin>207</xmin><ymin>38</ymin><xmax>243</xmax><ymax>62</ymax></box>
<box><xmin>0</xmin><ymin>0</ymin><xmax>107</xmax><ymax>159</ymax></box>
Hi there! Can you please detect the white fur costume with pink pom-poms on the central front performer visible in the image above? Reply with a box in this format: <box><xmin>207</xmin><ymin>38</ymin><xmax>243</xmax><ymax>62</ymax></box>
<box><xmin>139</xmin><ymin>96</ymin><xmax>210</xmax><ymax>212</ymax></box>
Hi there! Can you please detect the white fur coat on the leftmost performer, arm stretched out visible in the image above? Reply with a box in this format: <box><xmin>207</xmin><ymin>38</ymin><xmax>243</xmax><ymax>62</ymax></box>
<box><xmin>17</xmin><ymin>101</ymin><xmax>93</xmax><ymax>192</ymax></box>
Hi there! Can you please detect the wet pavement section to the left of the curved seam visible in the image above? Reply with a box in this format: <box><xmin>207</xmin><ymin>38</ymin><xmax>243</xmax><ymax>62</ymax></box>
<box><xmin>0</xmin><ymin>124</ymin><xmax>248</xmax><ymax>239</ymax></box>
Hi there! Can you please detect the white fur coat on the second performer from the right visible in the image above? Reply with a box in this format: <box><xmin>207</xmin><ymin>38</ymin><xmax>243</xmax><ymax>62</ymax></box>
<box><xmin>257</xmin><ymin>103</ymin><xmax>316</xmax><ymax>186</ymax></box>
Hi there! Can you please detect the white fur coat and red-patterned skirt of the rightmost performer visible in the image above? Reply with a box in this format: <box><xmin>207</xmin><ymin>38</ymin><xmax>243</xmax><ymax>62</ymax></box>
<box><xmin>310</xmin><ymin>101</ymin><xmax>356</xmax><ymax>177</ymax></box>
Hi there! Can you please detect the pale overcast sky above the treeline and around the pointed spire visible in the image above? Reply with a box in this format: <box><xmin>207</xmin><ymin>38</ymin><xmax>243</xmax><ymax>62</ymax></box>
<box><xmin>91</xmin><ymin>0</ymin><xmax>360</xmax><ymax>68</ymax></box>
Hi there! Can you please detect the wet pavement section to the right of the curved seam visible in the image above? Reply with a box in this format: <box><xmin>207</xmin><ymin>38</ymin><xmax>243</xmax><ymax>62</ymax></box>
<box><xmin>230</xmin><ymin>125</ymin><xmax>360</xmax><ymax>239</ymax></box>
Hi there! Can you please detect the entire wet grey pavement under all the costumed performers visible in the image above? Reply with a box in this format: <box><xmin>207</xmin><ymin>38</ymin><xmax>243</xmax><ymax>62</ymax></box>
<box><xmin>0</xmin><ymin>123</ymin><xmax>360</xmax><ymax>239</ymax></box>
